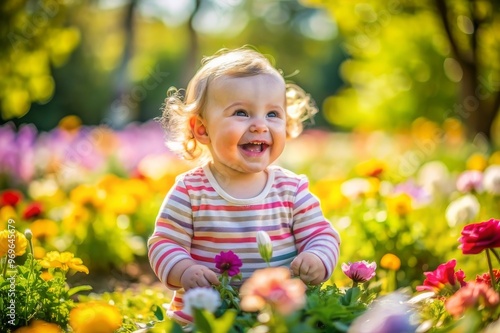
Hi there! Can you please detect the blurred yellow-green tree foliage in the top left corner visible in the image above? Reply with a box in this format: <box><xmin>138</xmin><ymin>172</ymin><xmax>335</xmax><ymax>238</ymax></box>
<box><xmin>0</xmin><ymin>0</ymin><xmax>80</xmax><ymax>119</ymax></box>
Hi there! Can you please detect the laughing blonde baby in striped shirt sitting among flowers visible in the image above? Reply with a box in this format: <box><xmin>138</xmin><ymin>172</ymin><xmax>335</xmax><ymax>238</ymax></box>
<box><xmin>148</xmin><ymin>48</ymin><xmax>340</xmax><ymax>322</ymax></box>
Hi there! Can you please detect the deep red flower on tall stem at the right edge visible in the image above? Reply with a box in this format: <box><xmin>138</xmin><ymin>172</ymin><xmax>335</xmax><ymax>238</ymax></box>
<box><xmin>458</xmin><ymin>219</ymin><xmax>500</xmax><ymax>254</ymax></box>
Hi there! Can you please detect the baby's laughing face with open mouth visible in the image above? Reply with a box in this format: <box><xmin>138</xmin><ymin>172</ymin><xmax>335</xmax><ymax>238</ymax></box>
<box><xmin>198</xmin><ymin>74</ymin><xmax>286</xmax><ymax>173</ymax></box>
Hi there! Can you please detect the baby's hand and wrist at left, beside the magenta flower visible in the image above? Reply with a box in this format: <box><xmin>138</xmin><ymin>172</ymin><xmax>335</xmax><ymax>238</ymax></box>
<box><xmin>167</xmin><ymin>259</ymin><xmax>219</xmax><ymax>290</ymax></box>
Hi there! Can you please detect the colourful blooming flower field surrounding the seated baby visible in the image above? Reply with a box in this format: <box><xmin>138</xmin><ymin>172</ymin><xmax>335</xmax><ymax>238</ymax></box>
<box><xmin>0</xmin><ymin>116</ymin><xmax>500</xmax><ymax>333</ymax></box>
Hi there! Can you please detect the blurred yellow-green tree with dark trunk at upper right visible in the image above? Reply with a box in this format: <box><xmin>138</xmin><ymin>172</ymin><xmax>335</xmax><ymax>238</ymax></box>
<box><xmin>301</xmin><ymin>0</ymin><xmax>500</xmax><ymax>138</ymax></box>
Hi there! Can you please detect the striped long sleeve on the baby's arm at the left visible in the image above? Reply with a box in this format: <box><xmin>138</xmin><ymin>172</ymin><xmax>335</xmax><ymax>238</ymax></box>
<box><xmin>148</xmin><ymin>177</ymin><xmax>193</xmax><ymax>290</ymax></box>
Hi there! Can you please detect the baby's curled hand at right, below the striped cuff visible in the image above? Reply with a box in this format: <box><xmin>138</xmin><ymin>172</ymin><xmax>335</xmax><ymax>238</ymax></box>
<box><xmin>290</xmin><ymin>252</ymin><xmax>326</xmax><ymax>284</ymax></box>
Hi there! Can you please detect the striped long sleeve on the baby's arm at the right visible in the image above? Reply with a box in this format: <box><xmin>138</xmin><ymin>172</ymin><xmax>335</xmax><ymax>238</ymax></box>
<box><xmin>293</xmin><ymin>177</ymin><xmax>340</xmax><ymax>279</ymax></box>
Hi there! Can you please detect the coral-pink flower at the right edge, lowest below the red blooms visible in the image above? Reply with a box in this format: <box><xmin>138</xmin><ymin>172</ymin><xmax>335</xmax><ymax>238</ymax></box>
<box><xmin>445</xmin><ymin>282</ymin><xmax>500</xmax><ymax>318</ymax></box>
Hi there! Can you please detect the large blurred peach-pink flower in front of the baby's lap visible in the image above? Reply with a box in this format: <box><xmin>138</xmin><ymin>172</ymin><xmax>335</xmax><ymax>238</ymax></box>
<box><xmin>240</xmin><ymin>267</ymin><xmax>306</xmax><ymax>315</ymax></box>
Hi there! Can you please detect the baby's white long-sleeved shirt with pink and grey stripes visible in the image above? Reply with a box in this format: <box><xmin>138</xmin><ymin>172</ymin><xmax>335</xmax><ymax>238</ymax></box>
<box><xmin>148</xmin><ymin>164</ymin><xmax>340</xmax><ymax>322</ymax></box>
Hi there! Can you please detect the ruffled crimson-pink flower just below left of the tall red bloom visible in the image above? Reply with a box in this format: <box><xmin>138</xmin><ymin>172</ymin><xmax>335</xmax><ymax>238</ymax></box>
<box><xmin>417</xmin><ymin>259</ymin><xmax>467</xmax><ymax>294</ymax></box>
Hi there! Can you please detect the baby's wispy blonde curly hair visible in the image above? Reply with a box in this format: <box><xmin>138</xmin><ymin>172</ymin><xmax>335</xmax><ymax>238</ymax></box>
<box><xmin>157</xmin><ymin>47</ymin><xmax>318</xmax><ymax>160</ymax></box>
